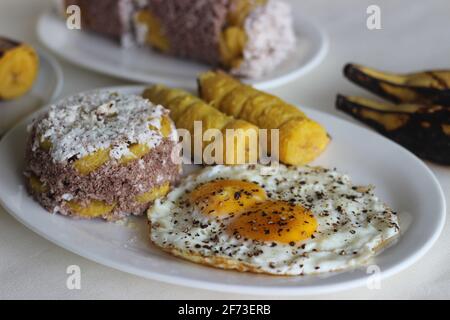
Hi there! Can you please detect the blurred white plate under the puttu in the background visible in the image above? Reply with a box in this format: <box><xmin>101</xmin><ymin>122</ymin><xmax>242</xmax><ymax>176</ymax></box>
<box><xmin>37</xmin><ymin>4</ymin><xmax>328</xmax><ymax>89</ymax></box>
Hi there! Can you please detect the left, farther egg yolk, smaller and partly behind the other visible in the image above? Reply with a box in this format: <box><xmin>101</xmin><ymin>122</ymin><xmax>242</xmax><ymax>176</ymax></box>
<box><xmin>190</xmin><ymin>180</ymin><xmax>267</xmax><ymax>217</ymax></box>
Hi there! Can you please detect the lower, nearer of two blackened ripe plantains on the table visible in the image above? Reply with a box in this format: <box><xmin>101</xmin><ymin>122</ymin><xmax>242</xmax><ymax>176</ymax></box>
<box><xmin>336</xmin><ymin>95</ymin><xmax>450</xmax><ymax>165</ymax></box>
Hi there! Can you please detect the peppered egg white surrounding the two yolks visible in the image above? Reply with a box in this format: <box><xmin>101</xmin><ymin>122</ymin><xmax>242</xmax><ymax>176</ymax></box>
<box><xmin>148</xmin><ymin>165</ymin><xmax>400</xmax><ymax>275</ymax></box>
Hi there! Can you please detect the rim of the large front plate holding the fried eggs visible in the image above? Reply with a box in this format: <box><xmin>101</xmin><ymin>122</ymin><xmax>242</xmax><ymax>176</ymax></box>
<box><xmin>0</xmin><ymin>85</ymin><xmax>446</xmax><ymax>296</ymax></box>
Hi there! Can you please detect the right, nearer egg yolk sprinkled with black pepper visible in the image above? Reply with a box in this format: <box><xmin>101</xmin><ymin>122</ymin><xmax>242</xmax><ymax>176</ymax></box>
<box><xmin>227</xmin><ymin>200</ymin><xmax>317</xmax><ymax>245</ymax></box>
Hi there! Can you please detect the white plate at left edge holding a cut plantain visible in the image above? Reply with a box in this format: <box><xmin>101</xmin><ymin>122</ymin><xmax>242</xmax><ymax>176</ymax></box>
<box><xmin>0</xmin><ymin>49</ymin><xmax>63</xmax><ymax>136</ymax></box>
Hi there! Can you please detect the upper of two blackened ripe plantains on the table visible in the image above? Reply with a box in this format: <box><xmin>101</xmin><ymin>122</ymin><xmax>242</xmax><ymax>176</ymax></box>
<box><xmin>344</xmin><ymin>64</ymin><xmax>450</xmax><ymax>105</ymax></box>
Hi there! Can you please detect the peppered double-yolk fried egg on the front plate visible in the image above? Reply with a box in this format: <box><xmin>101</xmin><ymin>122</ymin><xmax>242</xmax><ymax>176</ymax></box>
<box><xmin>148</xmin><ymin>165</ymin><xmax>400</xmax><ymax>275</ymax></box>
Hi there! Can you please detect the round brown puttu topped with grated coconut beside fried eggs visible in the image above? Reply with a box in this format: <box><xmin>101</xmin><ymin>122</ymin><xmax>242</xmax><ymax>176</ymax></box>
<box><xmin>25</xmin><ymin>91</ymin><xmax>181</xmax><ymax>220</ymax></box>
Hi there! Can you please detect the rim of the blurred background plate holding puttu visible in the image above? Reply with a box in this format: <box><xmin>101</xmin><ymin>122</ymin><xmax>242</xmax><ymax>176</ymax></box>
<box><xmin>36</xmin><ymin>8</ymin><xmax>330</xmax><ymax>90</ymax></box>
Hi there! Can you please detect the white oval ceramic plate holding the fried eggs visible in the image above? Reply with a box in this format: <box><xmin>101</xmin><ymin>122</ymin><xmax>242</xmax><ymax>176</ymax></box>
<box><xmin>0</xmin><ymin>87</ymin><xmax>445</xmax><ymax>295</ymax></box>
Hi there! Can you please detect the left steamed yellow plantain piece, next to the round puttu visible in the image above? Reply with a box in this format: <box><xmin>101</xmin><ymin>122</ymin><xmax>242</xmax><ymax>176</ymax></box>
<box><xmin>143</xmin><ymin>85</ymin><xmax>259</xmax><ymax>165</ymax></box>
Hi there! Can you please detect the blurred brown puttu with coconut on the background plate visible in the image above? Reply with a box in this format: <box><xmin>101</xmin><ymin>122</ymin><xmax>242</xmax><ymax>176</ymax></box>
<box><xmin>63</xmin><ymin>0</ymin><xmax>296</xmax><ymax>78</ymax></box>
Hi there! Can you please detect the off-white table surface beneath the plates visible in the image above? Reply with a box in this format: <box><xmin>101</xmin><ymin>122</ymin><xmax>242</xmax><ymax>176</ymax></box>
<box><xmin>0</xmin><ymin>0</ymin><xmax>450</xmax><ymax>299</ymax></box>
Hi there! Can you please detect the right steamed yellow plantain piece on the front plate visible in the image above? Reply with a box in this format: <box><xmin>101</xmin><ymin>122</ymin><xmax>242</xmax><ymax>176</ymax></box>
<box><xmin>198</xmin><ymin>71</ymin><xmax>329</xmax><ymax>165</ymax></box>
